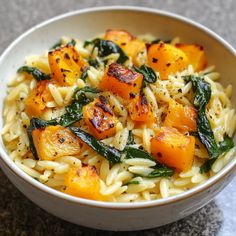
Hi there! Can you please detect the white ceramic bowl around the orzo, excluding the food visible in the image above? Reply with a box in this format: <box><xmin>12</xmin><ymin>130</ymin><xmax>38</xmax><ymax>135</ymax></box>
<box><xmin>0</xmin><ymin>7</ymin><xmax>236</xmax><ymax>230</ymax></box>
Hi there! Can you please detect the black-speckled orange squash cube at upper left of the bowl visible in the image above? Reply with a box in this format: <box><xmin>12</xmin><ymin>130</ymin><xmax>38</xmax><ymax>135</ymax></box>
<box><xmin>48</xmin><ymin>44</ymin><xmax>88</xmax><ymax>86</ymax></box>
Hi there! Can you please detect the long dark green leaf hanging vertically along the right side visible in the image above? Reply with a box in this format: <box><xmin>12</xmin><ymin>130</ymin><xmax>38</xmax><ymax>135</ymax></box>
<box><xmin>184</xmin><ymin>76</ymin><xmax>234</xmax><ymax>173</ymax></box>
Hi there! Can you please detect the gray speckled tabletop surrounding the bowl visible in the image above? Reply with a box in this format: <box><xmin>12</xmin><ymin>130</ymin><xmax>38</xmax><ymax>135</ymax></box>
<box><xmin>0</xmin><ymin>0</ymin><xmax>236</xmax><ymax>236</ymax></box>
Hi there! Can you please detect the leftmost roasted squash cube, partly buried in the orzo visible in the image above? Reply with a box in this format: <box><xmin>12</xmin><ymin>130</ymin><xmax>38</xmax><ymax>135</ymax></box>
<box><xmin>24</xmin><ymin>80</ymin><xmax>53</xmax><ymax>117</ymax></box>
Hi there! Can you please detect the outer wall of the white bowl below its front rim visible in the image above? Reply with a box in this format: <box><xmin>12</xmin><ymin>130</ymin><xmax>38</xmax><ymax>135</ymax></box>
<box><xmin>0</xmin><ymin>155</ymin><xmax>235</xmax><ymax>231</ymax></box>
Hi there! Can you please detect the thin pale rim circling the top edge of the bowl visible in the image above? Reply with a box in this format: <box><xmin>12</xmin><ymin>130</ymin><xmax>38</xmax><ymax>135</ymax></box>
<box><xmin>0</xmin><ymin>6</ymin><xmax>236</xmax><ymax>210</ymax></box>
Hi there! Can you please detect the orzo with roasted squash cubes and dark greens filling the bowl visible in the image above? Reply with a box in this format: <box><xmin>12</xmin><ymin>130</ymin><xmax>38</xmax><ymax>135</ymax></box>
<box><xmin>2</xmin><ymin>29</ymin><xmax>236</xmax><ymax>202</ymax></box>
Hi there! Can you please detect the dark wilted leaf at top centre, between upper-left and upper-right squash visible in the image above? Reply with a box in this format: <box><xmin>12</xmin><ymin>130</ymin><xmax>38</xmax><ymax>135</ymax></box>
<box><xmin>92</xmin><ymin>38</ymin><xmax>129</xmax><ymax>64</ymax></box>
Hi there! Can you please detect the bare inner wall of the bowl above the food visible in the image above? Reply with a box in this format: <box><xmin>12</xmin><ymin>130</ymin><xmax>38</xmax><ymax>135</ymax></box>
<box><xmin>0</xmin><ymin>8</ymin><xmax>236</xmax><ymax>206</ymax></box>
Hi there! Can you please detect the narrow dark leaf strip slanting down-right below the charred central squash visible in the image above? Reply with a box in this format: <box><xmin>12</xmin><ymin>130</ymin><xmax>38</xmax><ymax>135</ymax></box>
<box><xmin>70</xmin><ymin>127</ymin><xmax>122</xmax><ymax>164</ymax></box>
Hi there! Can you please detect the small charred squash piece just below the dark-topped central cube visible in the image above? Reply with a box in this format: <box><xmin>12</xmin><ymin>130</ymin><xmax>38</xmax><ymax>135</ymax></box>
<box><xmin>128</xmin><ymin>94</ymin><xmax>154</xmax><ymax>123</ymax></box>
